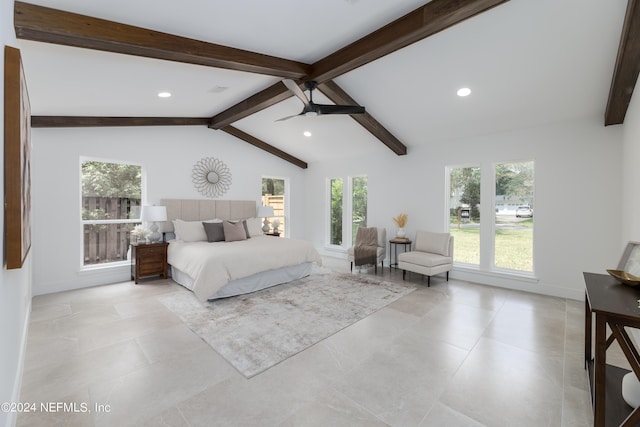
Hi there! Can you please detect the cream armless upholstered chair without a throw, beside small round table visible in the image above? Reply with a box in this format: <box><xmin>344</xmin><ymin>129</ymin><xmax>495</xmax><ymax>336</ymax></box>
<box><xmin>398</xmin><ymin>231</ymin><xmax>453</xmax><ymax>286</ymax></box>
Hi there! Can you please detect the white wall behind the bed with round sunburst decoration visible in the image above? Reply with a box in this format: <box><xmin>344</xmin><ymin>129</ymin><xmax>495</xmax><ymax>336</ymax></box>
<box><xmin>32</xmin><ymin>127</ymin><xmax>304</xmax><ymax>295</ymax></box>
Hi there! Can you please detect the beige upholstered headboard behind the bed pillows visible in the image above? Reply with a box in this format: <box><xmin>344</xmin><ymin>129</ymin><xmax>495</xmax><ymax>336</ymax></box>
<box><xmin>158</xmin><ymin>199</ymin><xmax>256</xmax><ymax>233</ymax></box>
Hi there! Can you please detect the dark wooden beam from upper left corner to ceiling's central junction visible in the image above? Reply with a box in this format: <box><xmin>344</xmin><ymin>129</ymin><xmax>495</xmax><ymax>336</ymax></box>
<box><xmin>14</xmin><ymin>1</ymin><xmax>310</xmax><ymax>79</ymax></box>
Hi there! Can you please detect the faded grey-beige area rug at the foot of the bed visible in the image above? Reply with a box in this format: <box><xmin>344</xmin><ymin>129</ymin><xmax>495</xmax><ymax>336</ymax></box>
<box><xmin>159</xmin><ymin>273</ymin><xmax>415</xmax><ymax>378</ymax></box>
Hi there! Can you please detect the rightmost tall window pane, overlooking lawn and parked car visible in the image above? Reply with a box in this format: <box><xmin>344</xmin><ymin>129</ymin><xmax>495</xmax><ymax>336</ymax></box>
<box><xmin>494</xmin><ymin>161</ymin><xmax>534</xmax><ymax>272</ymax></box>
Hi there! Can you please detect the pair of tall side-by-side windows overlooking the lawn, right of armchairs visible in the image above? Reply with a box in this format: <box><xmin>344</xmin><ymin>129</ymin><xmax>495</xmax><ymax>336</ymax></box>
<box><xmin>446</xmin><ymin>161</ymin><xmax>535</xmax><ymax>273</ymax></box>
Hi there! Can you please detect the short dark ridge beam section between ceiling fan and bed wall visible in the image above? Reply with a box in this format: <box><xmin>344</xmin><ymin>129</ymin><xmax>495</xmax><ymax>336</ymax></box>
<box><xmin>209</xmin><ymin>82</ymin><xmax>292</xmax><ymax>129</ymax></box>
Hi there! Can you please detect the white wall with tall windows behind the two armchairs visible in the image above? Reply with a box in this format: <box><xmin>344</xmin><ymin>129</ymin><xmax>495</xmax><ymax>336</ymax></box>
<box><xmin>306</xmin><ymin>118</ymin><xmax>622</xmax><ymax>299</ymax></box>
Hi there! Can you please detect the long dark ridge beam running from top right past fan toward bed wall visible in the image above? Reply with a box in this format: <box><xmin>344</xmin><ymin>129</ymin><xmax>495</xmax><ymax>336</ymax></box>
<box><xmin>211</xmin><ymin>0</ymin><xmax>508</xmax><ymax>129</ymax></box>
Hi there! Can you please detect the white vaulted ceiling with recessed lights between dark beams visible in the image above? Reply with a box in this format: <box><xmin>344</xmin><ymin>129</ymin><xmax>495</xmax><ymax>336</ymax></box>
<box><xmin>19</xmin><ymin>0</ymin><xmax>627</xmax><ymax>162</ymax></box>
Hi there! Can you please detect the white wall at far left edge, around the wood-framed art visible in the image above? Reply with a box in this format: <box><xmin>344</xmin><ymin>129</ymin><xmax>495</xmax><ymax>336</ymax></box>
<box><xmin>0</xmin><ymin>0</ymin><xmax>32</xmax><ymax>426</ymax></box>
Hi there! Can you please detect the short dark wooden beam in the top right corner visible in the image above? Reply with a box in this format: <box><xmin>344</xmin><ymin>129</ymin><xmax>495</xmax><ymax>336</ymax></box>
<box><xmin>604</xmin><ymin>0</ymin><xmax>640</xmax><ymax>126</ymax></box>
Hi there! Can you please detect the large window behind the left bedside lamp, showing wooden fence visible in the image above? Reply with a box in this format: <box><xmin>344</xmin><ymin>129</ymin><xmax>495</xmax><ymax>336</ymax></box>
<box><xmin>81</xmin><ymin>161</ymin><xmax>142</xmax><ymax>266</ymax></box>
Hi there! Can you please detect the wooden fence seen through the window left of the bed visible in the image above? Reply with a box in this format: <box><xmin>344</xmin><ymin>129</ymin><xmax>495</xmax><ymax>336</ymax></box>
<box><xmin>82</xmin><ymin>197</ymin><xmax>141</xmax><ymax>265</ymax></box>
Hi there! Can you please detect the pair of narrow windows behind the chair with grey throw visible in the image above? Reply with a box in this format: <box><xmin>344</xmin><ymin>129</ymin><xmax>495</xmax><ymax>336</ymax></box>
<box><xmin>328</xmin><ymin>176</ymin><xmax>368</xmax><ymax>246</ymax></box>
